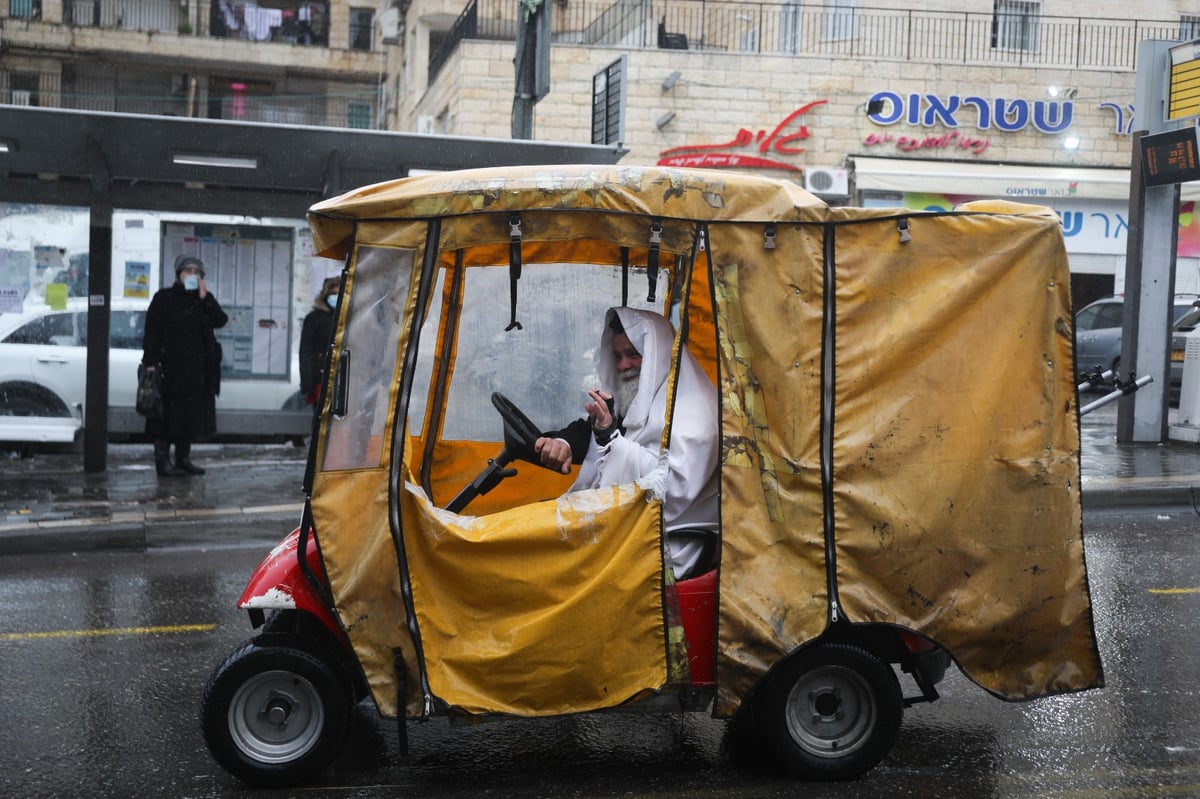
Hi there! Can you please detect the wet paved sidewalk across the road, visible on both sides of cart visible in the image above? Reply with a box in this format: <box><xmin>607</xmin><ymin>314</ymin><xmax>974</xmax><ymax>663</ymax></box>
<box><xmin>0</xmin><ymin>404</ymin><xmax>1200</xmax><ymax>554</ymax></box>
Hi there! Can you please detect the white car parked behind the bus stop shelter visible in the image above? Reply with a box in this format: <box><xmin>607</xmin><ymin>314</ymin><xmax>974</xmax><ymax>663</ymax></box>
<box><xmin>0</xmin><ymin>298</ymin><xmax>302</xmax><ymax>443</ymax></box>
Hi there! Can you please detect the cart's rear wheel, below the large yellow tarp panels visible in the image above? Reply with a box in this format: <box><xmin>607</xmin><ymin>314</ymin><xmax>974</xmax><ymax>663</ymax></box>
<box><xmin>755</xmin><ymin>644</ymin><xmax>904</xmax><ymax>780</ymax></box>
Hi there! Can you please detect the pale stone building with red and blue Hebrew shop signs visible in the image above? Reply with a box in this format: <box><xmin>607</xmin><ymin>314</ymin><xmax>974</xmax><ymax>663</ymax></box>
<box><xmin>392</xmin><ymin>0</ymin><xmax>1200</xmax><ymax>300</ymax></box>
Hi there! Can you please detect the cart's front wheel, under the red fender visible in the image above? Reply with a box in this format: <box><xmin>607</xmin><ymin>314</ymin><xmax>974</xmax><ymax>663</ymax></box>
<box><xmin>200</xmin><ymin>635</ymin><xmax>353</xmax><ymax>787</ymax></box>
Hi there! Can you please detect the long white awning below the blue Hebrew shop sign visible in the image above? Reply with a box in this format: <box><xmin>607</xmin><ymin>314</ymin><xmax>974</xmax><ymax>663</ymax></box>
<box><xmin>852</xmin><ymin>156</ymin><xmax>1200</xmax><ymax>203</ymax></box>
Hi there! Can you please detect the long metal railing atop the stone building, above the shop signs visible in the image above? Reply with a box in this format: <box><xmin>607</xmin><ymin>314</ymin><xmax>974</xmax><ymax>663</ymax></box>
<box><xmin>430</xmin><ymin>0</ymin><xmax>1190</xmax><ymax>80</ymax></box>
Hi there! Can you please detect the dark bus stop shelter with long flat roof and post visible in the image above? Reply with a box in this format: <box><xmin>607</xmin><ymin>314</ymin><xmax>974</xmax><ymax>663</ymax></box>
<box><xmin>0</xmin><ymin>106</ymin><xmax>625</xmax><ymax>471</ymax></box>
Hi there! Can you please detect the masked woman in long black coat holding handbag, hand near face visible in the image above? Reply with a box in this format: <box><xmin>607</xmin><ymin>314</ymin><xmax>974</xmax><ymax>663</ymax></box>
<box><xmin>142</xmin><ymin>256</ymin><xmax>229</xmax><ymax>477</ymax></box>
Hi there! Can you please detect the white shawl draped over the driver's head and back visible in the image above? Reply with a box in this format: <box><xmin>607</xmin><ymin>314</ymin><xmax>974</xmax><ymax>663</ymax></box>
<box><xmin>571</xmin><ymin>307</ymin><xmax>720</xmax><ymax>542</ymax></box>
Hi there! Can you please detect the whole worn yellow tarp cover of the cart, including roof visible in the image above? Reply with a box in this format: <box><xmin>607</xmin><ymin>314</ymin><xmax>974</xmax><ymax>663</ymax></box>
<box><xmin>310</xmin><ymin>167</ymin><xmax>1103</xmax><ymax>715</ymax></box>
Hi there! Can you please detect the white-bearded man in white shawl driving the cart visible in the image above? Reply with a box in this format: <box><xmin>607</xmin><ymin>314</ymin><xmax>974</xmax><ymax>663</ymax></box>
<box><xmin>534</xmin><ymin>307</ymin><xmax>719</xmax><ymax>579</ymax></box>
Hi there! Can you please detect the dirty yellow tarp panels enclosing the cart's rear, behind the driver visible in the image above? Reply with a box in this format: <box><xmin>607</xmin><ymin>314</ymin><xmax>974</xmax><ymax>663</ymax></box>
<box><xmin>712</xmin><ymin>205</ymin><xmax>1102</xmax><ymax>708</ymax></box>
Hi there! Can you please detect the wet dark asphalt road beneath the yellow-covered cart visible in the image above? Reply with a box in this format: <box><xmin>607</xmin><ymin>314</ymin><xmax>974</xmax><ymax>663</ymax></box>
<box><xmin>0</xmin><ymin>507</ymin><xmax>1200</xmax><ymax>799</ymax></box>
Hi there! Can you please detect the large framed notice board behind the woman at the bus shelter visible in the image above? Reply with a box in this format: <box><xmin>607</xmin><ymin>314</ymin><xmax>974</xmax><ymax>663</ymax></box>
<box><xmin>161</xmin><ymin>222</ymin><xmax>295</xmax><ymax>379</ymax></box>
